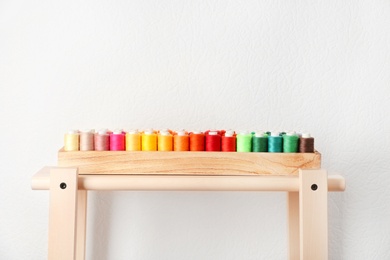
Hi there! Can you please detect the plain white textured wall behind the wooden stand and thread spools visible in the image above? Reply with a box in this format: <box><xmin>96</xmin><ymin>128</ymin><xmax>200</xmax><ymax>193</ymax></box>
<box><xmin>0</xmin><ymin>0</ymin><xmax>390</xmax><ymax>260</ymax></box>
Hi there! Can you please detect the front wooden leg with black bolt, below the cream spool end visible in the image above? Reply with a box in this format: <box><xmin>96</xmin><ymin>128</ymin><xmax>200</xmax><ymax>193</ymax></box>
<box><xmin>48</xmin><ymin>168</ymin><xmax>77</xmax><ymax>260</ymax></box>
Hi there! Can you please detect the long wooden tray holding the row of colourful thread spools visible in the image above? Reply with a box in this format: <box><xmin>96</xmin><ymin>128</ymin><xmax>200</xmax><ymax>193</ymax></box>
<box><xmin>58</xmin><ymin>149</ymin><xmax>321</xmax><ymax>175</ymax></box>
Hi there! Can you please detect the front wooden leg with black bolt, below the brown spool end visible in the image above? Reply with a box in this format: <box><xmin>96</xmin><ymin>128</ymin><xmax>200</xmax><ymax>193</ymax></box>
<box><xmin>299</xmin><ymin>170</ymin><xmax>328</xmax><ymax>260</ymax></box>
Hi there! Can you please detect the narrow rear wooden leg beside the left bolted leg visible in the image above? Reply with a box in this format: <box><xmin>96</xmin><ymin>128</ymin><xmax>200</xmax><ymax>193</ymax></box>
<box><xmin>76</xmin><ymin>190</ymin><xmax>87</xmax><ymax>260</ymax></box>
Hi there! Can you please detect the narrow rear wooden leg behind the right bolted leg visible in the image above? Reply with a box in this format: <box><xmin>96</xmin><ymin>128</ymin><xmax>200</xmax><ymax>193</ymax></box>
<box><xmin>287</xmin><ymin>192</ymin><xmax>300</xmax><ymax>260</ymax></box>
